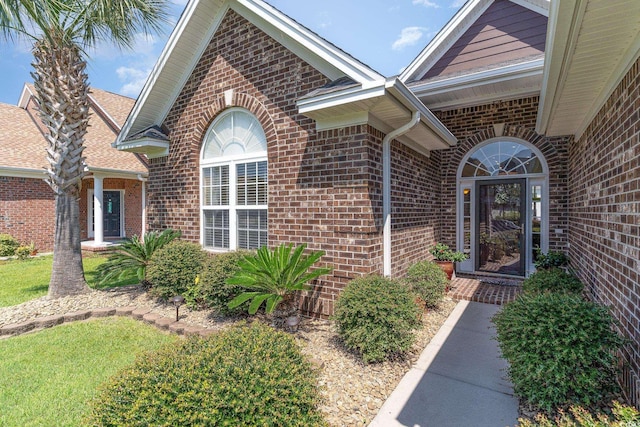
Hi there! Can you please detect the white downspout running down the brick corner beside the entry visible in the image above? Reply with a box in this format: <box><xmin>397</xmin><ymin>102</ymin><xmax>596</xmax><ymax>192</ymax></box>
<box><xmin>382</xmin><ymin>111</ymin><xmax>420</xmax><ymax>276</ymax></box>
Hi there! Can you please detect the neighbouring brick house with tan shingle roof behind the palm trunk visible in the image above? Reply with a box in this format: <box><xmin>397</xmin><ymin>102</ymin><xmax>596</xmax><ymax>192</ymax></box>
<box><xmin>0</xmin><ymin>85</ymin><xmax>148</xmax><ymax>251</ymax></box>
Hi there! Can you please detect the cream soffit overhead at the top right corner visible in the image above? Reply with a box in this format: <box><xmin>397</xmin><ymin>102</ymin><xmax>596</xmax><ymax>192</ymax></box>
<box><xmin>536</xmin><ymin>0</ymin><xmax>640</xmax><ymax>137</ymax></box>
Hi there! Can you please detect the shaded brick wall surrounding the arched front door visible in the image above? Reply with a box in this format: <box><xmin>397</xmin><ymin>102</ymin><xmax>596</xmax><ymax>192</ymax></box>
<box><xmin>434</xmin><ymin>97</ymin><xmax>569</xmax><ymax>251</ymax></box>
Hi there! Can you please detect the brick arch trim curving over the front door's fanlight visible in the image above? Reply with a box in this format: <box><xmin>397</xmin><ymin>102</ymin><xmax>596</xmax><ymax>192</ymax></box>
<box><xmin>445</xmin><ymin>125</ymin><xmax>558</xmax><ymax>178</ymax></box>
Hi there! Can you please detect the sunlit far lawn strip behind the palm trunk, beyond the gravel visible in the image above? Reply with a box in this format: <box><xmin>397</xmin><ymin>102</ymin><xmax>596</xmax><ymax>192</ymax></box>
<box><xmin>0</xmin><ymin>255</ymin><xmax>138</xmax><ymax>307</ymax></box>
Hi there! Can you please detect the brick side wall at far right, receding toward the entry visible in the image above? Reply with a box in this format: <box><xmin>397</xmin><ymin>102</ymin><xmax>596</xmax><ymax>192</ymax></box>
<box><xmin>569</xmin><ymin>57</ymin><xmax>640</xmax><ymax>405</ymax></box>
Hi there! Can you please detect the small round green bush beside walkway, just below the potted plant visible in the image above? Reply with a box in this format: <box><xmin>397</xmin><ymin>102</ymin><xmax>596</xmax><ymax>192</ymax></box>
<box><xmin>407</xmin><ymin>261</ymin><xmax>449</xmax><ymax>308</ymax></box>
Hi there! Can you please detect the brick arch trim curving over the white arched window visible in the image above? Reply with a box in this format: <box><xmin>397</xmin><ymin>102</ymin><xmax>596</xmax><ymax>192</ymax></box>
<box><xmin>195</xmin><ymin>91</ymin><xmax>276</xmax><ymax>149</ymax></box>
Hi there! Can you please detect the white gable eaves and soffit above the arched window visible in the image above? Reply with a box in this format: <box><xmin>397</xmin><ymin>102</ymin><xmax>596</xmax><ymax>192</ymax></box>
<box><xmin>116</xmin><ymin>0</ymin><xmax>384</xmax><ymax>150</ymax></box>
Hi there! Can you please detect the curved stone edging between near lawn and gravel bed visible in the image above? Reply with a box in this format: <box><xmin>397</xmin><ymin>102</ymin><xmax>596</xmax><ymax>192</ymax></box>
<box><xmin>0</xmin><ymin>306</ymin><xmax>216</xmax><ymax>339</ymax></box>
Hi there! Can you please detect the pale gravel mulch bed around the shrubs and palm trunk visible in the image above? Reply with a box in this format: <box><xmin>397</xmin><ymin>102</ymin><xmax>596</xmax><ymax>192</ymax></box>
<box><xmin>0</xmin><ymin>286</ymin><xmax>456</xmax><ymax>427</ymax></box>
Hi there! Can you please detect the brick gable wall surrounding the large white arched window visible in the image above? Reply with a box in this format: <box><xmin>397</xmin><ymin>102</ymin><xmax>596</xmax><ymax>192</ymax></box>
<box><xmin>148</xmin><ymin>11</ymin><xmax>390</xmax><ymax>316</ymax></box>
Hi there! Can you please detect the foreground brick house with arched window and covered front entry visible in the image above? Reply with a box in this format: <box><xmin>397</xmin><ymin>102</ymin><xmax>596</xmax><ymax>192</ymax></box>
<box><xmin>117</xmin><ymin>0</ymin><xmax>640</xmax><ymax>404</ymax></box>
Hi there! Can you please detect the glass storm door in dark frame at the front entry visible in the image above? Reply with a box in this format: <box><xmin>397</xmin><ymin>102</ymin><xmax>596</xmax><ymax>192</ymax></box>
<box><xmin>475</xmin><ymin>179</ymin><xmax>527</xmax><ymax>276</ymax></box>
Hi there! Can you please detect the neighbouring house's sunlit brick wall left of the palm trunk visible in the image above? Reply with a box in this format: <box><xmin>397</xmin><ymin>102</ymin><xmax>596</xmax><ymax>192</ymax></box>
<box><xmin>0</xmin><ymin>176</ymin><xmax>55</xmax><ymax>251</ymax></box>
